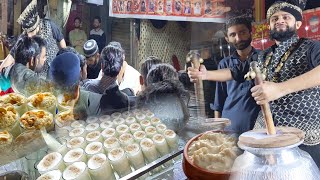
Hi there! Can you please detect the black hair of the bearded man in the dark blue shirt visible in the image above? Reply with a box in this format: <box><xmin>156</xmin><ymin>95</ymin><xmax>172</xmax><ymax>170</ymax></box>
<box><xmin>224</xmin><ymin>14</ymin><xmax>252</xmax><ymax>36</ymax></box>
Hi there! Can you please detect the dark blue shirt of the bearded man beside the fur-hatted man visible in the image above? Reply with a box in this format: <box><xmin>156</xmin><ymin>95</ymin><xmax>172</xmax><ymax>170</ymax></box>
<box><xmin>212</xmin><ymin>49</ymin><xmax>261</xmax><ymax>133</ymax></box>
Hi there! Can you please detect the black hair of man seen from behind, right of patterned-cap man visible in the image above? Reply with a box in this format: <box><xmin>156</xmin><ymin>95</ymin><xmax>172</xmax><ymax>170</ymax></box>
<box><xmin>100</xmin><ymin>45</ymin><xmax>124</xmax><ymax>77</ymax></box>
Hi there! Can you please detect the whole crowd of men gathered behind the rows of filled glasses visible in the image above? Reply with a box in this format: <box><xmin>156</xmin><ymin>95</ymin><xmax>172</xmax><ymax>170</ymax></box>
<box><xmin>0</xmin><ymin>1</ymin><xmax>189</xmax><ymax>134</ymax></box>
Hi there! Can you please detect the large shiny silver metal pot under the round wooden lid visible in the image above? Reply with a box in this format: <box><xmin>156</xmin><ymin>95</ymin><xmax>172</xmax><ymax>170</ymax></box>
<box><xmin>231</xmin><ymin>137</ymin><xmax>320</xmax><ymax>180</ymax></box>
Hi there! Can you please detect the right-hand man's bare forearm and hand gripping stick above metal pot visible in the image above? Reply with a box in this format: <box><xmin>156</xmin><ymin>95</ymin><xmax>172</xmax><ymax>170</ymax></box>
<box><xmin>251</xmin><ymin>42</ymin><xmax>320</xmax><ymax>105</ymax></box>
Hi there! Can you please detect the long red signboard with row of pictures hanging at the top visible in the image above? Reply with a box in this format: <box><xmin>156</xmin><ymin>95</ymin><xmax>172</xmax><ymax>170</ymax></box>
<box><xmin>109</xmin><ymin>0</ymin><xmax>231</xmax><ymax>23</ymax></box>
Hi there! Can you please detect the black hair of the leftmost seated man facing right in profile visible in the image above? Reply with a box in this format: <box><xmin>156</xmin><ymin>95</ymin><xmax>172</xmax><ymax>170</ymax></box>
<box><xmin>14</xmin><ymin>35</ymin><xmax>46</xmax><ymax>65</ymax></box>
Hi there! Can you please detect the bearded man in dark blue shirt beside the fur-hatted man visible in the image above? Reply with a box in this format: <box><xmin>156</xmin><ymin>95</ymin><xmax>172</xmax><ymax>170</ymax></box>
<box><xmin>211</xmin><ymin>16</ymin><xmax>260</xmax><ymax>133</ymax></box>
